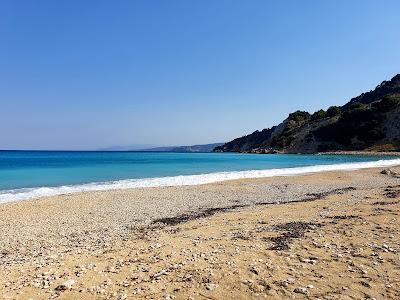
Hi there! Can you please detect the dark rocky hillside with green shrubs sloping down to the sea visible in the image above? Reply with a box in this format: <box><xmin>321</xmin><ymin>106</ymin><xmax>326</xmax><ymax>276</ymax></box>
<box><xmin>214</xmin><ymin>74</ymin><xmax>400</xmax><ymax>153</ymax></box>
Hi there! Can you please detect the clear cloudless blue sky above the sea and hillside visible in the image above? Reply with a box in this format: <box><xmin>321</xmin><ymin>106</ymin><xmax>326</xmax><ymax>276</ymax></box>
<box><xmin>0</xmin><ymin>0</ymin><xmax>400</xmax><ymax>149</ymax></box>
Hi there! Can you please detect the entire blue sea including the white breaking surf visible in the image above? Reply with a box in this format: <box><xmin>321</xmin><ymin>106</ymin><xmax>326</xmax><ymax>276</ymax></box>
<box><xmin>0</xmin><ymin>151</ymin><xmax>400</xmax><ymax>202</ymax></box>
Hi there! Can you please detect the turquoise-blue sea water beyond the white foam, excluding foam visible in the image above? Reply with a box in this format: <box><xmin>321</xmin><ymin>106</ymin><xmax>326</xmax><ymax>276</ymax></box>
<box><xmin>0</xmin><ymin>151</ymin><xmax>396</xmax><ymax>190</ymax></box>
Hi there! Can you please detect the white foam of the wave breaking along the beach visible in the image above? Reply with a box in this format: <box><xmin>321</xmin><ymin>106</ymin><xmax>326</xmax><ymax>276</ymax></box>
<box><xmin>0</xmin><ymin>159</ymin><xmax>400</xmax><ymax>203</ymax></box>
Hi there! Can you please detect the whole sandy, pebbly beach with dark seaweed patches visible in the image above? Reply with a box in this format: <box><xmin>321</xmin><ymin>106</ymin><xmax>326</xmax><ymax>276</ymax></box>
<box><xmin>0</xmin><ymin>167</ymin><xmax>400</xmax><ymax>299</ymax></box>
